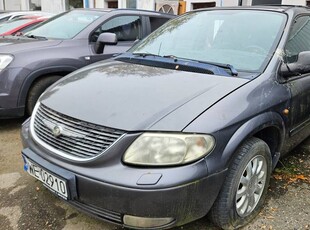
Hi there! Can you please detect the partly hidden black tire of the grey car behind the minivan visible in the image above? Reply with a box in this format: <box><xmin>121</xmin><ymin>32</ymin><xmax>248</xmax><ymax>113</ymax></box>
<box><xmin>25</xmin><ymin>75</ymin><xmax>62</xmax><ymax>116</ymax></box>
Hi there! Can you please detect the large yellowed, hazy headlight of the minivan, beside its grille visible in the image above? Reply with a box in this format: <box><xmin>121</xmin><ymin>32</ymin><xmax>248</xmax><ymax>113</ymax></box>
<box><xmin>123</xmin><ymin>133</ymin><xmax>215</xmax><ymax>166</ymax></box>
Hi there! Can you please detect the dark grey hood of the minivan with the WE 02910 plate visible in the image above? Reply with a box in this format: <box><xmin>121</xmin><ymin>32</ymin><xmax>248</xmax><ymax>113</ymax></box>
<box><xmin>40</xmin><ymin>61</ymin><xmax>249</xmax><ymax>131</ymax></box>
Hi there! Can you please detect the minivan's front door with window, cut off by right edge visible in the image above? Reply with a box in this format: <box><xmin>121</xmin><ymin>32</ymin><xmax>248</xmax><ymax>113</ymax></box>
<box><xmin>285</xmin><ymin>15</ymin><xmax>310</xmax><ymax>136</ymax></box>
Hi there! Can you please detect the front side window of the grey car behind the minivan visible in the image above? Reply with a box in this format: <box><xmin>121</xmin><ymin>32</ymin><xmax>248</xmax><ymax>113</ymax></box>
<box><xmin>90</xmin><ymin>16</ymin><xmax>141</xmax><ymax>42</ymax></box>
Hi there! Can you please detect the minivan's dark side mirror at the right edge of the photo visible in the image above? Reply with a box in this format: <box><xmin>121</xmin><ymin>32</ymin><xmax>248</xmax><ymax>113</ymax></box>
<box><xmin>280</xmin><ymin>51</ymin><xmax>310</xmax><ymax>77</ymax></box>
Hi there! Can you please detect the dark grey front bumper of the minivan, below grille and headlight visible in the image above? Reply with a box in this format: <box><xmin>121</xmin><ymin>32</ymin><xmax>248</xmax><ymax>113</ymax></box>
<box><xmin>22</xmin><ymin>121</ymin><xmax>226</xmax><ymax>229</ymax></box>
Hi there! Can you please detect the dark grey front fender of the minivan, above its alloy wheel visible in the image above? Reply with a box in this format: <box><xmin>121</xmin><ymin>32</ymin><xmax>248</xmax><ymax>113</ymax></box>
<box><xmin>183</xmin><ymin>74</ymin><xmax>290</xmax><ymax>173</ymax></box>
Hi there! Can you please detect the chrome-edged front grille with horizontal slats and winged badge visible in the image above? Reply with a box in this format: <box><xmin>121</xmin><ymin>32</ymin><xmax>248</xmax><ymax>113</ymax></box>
<box><xmin>33</xmin><ymin>104</ymin><xmax>124</xmax><ymax>160</ymax></box>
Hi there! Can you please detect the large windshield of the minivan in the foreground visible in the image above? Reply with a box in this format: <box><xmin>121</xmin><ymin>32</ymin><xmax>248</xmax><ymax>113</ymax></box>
<box><xmin>130</xmin><ymin>10</ymin><xmax>286</xmax><ymax>72</ymax></box>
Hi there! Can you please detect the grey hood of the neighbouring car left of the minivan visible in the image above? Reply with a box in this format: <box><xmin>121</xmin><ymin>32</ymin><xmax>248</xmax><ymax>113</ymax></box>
<box><xmin>0</xmin><ymin>36</ymin><xmax>62</xmax><ymax>54</ymax></box>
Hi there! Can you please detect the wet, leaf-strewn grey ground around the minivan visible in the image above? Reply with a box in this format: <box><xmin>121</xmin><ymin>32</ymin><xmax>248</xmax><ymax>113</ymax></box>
<box><xmin>0</xmin><ymin>119</ymin><xmax>310</xmax><ymax>230</ymax></box>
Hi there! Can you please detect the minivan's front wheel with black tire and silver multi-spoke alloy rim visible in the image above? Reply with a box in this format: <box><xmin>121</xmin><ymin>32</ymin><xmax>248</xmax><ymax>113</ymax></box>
<box><xmin>209</xmin><ymin>137</ymin><xmax>272</xmax><ymax>229</ymax></box>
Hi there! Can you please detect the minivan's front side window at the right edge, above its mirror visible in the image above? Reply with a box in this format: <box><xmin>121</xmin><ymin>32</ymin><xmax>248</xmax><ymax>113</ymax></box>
<box><xmin>285</xmin><ymin>16</ymin><xmax>310</xmax><ymax>63</ymax></box>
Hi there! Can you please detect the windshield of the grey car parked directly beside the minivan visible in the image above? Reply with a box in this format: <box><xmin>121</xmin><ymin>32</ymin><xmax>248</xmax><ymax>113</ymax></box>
<box><xmin>25</xmin><ymin>10</ymin><xmax>103</xmax><ymax>39</ymax></box>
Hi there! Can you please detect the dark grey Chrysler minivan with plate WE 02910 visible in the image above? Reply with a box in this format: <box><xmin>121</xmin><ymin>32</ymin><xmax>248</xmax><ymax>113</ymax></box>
<box><xmin>22</xmin><ymin>6</ymin><xmax>310</xmax><ymax>229</ymax></box>
